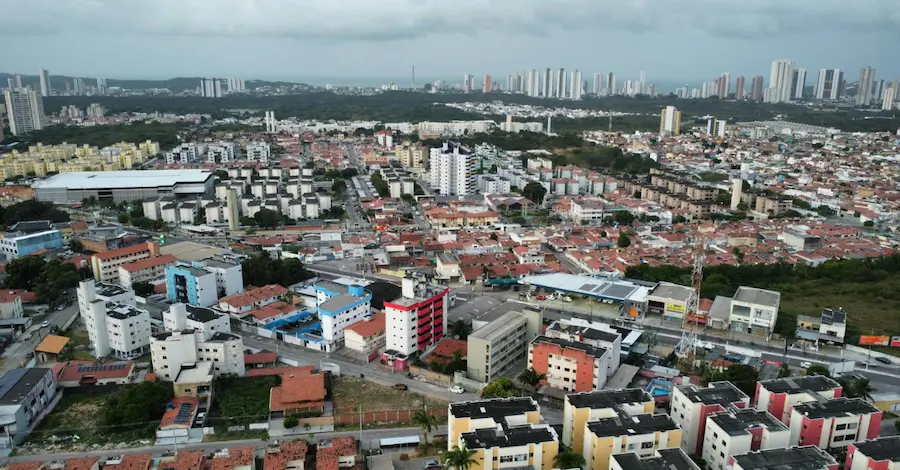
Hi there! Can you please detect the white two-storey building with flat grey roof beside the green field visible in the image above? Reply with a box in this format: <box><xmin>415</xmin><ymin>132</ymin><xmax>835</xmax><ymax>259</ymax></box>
<box><xmin>728</xmin><ymin>286</ymin><xmax>781</xmax><ymax>336</ymax></box>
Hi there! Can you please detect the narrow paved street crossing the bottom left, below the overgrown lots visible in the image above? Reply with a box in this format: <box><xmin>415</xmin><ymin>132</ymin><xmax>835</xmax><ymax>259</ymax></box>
<box><xmin>0</xmin><ymin>426</ymin><xmax>447</xmax><ymax>464</ymax></box>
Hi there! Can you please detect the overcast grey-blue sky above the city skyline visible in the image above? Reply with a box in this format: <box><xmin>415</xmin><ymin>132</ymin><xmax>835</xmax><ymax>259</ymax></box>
<box><xmin>0</xmin><ymin>0</ymin><xmax>900</xmax><ymax>85</ymax></box>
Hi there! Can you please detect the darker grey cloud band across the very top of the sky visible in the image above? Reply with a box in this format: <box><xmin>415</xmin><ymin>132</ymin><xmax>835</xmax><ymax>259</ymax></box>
<box><xmin>0</xmin><ymin>0</ymin><xmax>900</xmax><ymax>42</ymax></box>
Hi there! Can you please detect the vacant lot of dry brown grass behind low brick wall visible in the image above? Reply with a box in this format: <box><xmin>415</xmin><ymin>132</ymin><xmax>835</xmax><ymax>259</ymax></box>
<box><xmin>332</xmin><ymin>377</ymin><xmax>447</xmax><ymax>413</ymax></box>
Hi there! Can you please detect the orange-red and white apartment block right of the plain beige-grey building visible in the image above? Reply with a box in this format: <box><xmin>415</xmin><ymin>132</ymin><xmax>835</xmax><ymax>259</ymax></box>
<box><xmin>528</xmin><ymin>335</ymin><xmax>611</xmax><ymax>392</ymax></box>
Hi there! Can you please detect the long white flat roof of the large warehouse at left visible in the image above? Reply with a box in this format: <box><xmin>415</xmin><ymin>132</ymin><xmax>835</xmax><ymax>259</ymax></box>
<box><xmin>32</xmin><ymin>170</ymin><xmax>212</xmax><ymax>190</ymax></box>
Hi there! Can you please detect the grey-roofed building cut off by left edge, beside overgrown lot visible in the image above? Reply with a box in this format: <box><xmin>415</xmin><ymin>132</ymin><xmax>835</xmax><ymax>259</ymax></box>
<box><xmin>0</xmin><ymin>367</ymin><xmax>57</xmax><ymax>452</ymax></box>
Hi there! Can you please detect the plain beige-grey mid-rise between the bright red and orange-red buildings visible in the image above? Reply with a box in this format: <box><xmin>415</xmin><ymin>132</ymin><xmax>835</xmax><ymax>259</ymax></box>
<box><xmin>466</xmin><ymin>309</ymin><xmax>543</xmax><ymax>383</ymax></box>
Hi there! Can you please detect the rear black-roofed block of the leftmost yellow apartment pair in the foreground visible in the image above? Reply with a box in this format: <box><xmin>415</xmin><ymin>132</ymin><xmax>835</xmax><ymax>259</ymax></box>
<box><xmin>447</xmin><ymin>397</ymin><xmax>541</xmax><ymax>450</ymax></box>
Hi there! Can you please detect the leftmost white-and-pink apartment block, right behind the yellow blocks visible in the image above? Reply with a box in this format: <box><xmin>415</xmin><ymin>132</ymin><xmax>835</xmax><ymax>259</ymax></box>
<box><xmin>670</xmin><ymin>382</ymin><xmax>750</xmax><ymax>454</ymax></box>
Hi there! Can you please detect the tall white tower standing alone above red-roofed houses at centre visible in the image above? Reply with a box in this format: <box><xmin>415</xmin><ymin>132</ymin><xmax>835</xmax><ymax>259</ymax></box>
<box><xmin>428</xmin><ymin>142</ymin><xmax>478</xmax><ymax>196</ymax></box>
